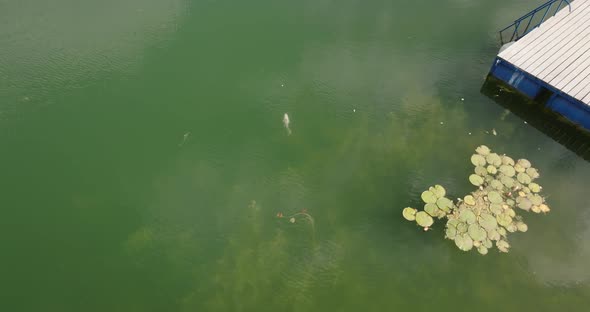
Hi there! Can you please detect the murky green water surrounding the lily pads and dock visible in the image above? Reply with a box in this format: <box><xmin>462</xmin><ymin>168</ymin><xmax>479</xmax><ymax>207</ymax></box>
<box><xmin>0</xmin><ymin>0</ymin><xmax>590</xmax><ymax>311</ymax></box>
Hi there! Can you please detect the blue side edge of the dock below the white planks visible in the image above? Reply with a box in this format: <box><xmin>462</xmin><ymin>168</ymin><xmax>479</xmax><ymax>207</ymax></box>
<box><xmin>490</xmin><ymin>57</ymin><xmax>590</xmax><ymax>131</ymax></box>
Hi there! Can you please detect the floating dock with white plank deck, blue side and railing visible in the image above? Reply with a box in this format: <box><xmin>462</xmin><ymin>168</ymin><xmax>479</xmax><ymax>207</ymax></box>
<box><xmin>490</xmin><ymin>0</ymin><xmax>590</xmax><ymax>130</ymax></box>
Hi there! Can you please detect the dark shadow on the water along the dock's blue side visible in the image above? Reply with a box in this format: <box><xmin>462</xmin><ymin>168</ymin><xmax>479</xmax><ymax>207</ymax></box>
<box><xmin>480</xmin><ymin>75</ymin><xmax>590</xmax><ymax>161</ymax></box>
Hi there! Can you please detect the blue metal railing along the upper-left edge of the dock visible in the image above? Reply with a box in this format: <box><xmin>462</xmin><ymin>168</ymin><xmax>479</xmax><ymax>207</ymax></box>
<box><xmin>500</xmin><ymin>0</ymin><xmax>572</xmax><ymax>45</ymax></box>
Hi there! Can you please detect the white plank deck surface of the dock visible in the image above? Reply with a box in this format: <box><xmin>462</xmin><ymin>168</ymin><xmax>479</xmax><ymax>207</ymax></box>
<box><xmin>498</xmin><ymin>0</ymin><xmax>590</xmax><ymax>105</ymax></box>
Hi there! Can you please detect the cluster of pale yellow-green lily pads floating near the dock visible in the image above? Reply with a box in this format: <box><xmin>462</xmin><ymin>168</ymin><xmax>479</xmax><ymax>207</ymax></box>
<box><xmin>402</xmin><ymin>145</ymin><xmax>550</xmax><ymax>255</ymax></box>
